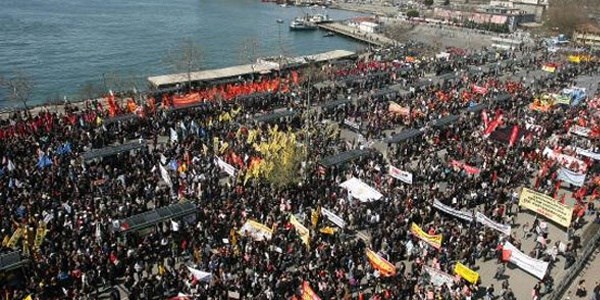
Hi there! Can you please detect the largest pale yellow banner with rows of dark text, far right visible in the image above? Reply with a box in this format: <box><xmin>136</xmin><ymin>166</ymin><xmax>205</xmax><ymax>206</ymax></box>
<box><xmin>519</xmin><ymin>187</ymin><xmax>573</xmax><ymax>227</ymax></box>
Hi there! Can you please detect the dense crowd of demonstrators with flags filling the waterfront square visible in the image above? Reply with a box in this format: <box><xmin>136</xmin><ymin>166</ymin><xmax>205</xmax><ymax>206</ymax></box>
<box><xmin>0</xmin><ymin>42</ymin><xmax>600</xmax><ymax>299</ymax></box>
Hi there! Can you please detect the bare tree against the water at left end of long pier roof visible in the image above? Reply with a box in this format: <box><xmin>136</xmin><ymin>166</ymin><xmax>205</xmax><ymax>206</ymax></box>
<box><xmin>165</xmin><ymin>39</ymin><xmax>203</xmax><ymax>88</ymax></box>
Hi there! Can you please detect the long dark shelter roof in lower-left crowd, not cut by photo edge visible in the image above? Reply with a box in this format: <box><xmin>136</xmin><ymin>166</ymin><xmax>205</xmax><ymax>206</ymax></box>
<box><xmin>119</xmin><ymin>201</ymin><xmax>197</xmax><ymax>232</ymax></box>
